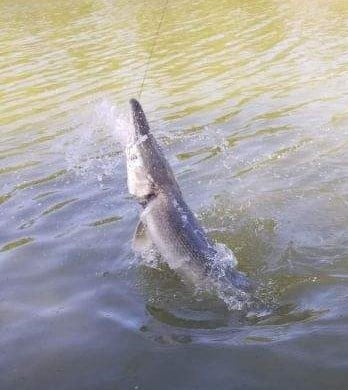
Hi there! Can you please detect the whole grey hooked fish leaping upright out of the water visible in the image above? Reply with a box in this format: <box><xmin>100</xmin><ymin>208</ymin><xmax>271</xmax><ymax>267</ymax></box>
<box><xmin>125</xmin><ymin>99</ymin><xmax>250</xmax><ymax>291</ymax></box>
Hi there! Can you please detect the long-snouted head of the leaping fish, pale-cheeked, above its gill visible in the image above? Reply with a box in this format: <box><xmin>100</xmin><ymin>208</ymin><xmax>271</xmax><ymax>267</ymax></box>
<box><xmin>126</xmin><ymin>99</ymin><xmax>180</xmax><ymax>204</ymax></box>
